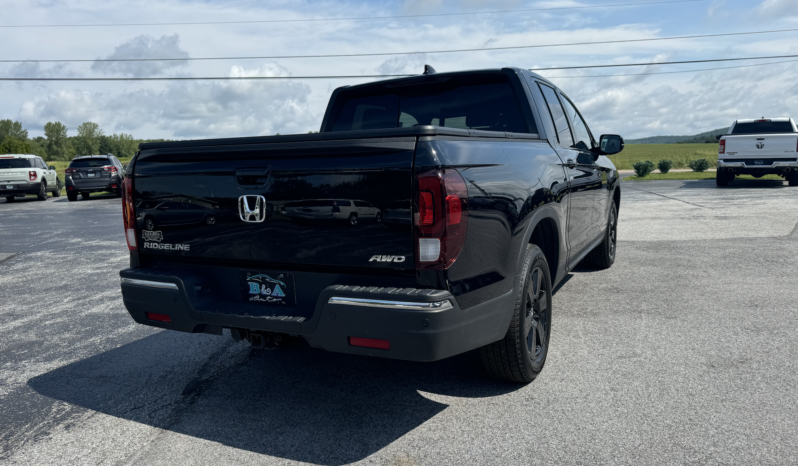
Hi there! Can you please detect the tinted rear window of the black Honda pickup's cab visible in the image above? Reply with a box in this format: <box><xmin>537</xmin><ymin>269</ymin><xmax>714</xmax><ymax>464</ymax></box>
<box><xmin>332</xmin><ymin>75</ymin><xmax>529</xmax><ymax>133</ymax></box>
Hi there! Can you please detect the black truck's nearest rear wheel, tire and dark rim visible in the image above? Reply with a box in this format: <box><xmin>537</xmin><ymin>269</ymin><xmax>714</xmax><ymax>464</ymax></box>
<box><xmin>479</xmin><ymin>244</ymin><xmax>552</xmax><ymax>384</ymax></box>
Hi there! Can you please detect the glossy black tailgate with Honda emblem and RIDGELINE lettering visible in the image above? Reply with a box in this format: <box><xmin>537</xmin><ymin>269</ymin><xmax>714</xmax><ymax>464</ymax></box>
<box><xmin>133</xmin><ymin>137</ymin><xmax>416</xmax><ymax>270</ymax></box>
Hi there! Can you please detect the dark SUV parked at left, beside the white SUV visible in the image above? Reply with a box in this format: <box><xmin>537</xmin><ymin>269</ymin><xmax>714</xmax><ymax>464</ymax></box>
<box><xmin>64</xmin><ymin>154</ymin><xmax>124</xmax><ymax>201</ymax></box>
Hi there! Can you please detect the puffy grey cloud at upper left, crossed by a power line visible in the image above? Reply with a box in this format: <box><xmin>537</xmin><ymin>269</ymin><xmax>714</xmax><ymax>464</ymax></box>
<box><xmin>91</xmin><ymin>34</ymin><xmax>189</xmax><ymax>77</ymax></box>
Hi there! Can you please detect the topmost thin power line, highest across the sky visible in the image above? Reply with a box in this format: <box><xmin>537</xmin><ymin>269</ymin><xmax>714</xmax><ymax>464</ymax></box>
<box><xmin>0</xmin><ymin>0</ymin><xmax>706</xmax><ymax>28</ymax></box>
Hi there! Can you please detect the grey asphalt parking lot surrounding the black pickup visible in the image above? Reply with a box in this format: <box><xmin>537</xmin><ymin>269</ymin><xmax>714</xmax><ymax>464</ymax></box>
<box><xmin>0</xmin><ymin>181</ymin><xmax>798</xmax><ymax>465</ymax></box>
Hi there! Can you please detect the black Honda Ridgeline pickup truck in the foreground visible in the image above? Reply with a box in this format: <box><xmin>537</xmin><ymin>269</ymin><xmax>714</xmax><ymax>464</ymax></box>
<box><xmin>120</xmin><ymin>68</ymin><xmax>624</xmax><ymax>383</ymax></box>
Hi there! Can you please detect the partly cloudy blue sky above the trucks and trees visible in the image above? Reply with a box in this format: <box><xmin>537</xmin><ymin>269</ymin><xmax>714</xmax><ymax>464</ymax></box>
<box><xmin>0</xmin><ymin>0</ymin><xmax>798</xmax><ymax>139</ymax></box>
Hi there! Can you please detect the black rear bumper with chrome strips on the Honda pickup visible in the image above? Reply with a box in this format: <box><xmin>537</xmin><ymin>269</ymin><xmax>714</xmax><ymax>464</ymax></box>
<box><xmin>120</xmin><ymin>269</ymin><xmax>513</xmax><ymax>361</ymax></box>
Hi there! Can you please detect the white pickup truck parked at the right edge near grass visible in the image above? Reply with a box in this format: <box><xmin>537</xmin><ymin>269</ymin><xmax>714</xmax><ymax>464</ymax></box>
<box><xmin>717</xmin><ymin>118</ymin><xmax>798</xmax><ymax>186</ymax></box>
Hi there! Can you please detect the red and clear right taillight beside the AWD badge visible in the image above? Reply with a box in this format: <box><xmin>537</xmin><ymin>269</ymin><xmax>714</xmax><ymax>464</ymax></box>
<box><xmin>415</xmin><ymin>170</ymin><xmax>468</xmax><ymax>270</ymax></box>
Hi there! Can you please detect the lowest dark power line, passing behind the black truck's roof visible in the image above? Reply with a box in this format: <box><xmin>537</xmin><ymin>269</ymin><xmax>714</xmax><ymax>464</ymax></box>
<box><xmin>0</xmin><ymin>54</ymin><xmax>798</xmax><ymax>81</ymax></box>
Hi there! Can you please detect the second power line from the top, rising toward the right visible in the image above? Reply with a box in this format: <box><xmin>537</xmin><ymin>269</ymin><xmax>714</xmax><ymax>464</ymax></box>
<box><xmin>0</xmin><ymin>28</ymin><xmax>798</xmax><ymax>63</ymax></box>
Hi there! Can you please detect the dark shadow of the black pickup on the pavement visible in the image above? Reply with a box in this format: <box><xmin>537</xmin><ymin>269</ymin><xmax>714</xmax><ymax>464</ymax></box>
<box><xmin>29</xmin><ymin>332</ymin><xmax>522</xmax><ymax>465</ymax></box>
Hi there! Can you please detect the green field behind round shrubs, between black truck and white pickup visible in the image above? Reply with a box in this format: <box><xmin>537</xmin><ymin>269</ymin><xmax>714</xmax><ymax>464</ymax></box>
<box><xmin>609</xmin><ymin>144</ymin><xmax>718</xmax><ymax>171</ymax></box>
